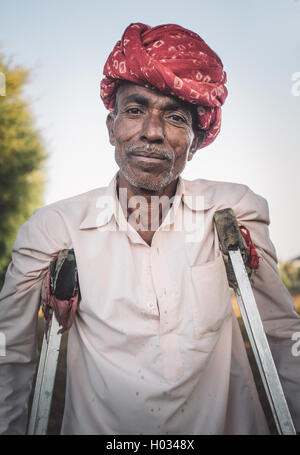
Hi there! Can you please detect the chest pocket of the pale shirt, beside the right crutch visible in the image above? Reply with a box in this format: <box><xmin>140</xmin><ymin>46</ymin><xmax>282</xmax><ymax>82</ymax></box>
<box><xmin>190</xmin><ymin>254</ymin><xmax>232</xmax><ymax>339</ymax></box>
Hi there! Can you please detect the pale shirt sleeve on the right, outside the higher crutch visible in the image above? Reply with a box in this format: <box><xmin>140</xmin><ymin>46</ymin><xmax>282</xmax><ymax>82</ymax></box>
<box><xmin>235</xmin><ymin>190</ymin><xmax>300</xmax><ymax>431</ymax></box>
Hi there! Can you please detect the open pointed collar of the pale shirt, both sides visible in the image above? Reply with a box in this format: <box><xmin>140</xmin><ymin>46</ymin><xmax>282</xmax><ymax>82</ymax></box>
<box><xmin>80</xmin><ymin>174</ymin><xmax>213</xmax><ymax>229</ymax></box>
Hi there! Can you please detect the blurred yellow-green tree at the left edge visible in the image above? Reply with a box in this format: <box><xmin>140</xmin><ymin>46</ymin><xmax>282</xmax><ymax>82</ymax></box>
<box><xmin>0</xmin><ymin>53</ymin><xmax>47</xmax><ymax>287</ymax></box>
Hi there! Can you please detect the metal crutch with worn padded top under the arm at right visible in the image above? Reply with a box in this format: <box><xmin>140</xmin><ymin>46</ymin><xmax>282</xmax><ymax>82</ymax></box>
<box><xmin>214</xmin><ymin>209</ymin><xmax>296</xmax><ymax>435</ymax></box>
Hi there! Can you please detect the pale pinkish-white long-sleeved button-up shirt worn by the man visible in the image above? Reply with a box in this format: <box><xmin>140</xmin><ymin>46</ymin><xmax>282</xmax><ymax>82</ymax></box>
<box><xmin>0</xmin><ymin>178</ymin><xmax>300</xmax><ymax>435</ymax></box>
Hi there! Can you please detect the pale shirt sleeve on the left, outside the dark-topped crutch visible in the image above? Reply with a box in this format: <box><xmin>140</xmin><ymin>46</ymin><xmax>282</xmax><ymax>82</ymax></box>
<box><xmin>0</xmin><ymin>208</ymin><xmax>69</xmax><ymax>434</ymax></box>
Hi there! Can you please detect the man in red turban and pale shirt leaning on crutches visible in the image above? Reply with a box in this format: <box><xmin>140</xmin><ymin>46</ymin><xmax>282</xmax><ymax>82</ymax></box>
<box><xmin>0</xmin><ymin>23</ymin><xmax>300</xmax><ymax>435</ymax></box>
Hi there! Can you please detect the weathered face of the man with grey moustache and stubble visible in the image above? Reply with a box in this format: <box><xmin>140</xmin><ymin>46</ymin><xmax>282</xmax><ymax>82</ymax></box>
<box><xmin>107</xmin><ymin>83</ymin><xmax>196</xmax><ymax>191</ymax></box>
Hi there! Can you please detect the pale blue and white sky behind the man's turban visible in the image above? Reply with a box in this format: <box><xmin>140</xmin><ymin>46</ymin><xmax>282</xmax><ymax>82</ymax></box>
<box><xmin>0</xmin><ymin>0</ymin><xmax>300</xmax><ymax>260</ymax></box>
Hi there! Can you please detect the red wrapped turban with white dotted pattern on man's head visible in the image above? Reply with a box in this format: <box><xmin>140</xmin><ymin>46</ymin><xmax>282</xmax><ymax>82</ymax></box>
<box><xmin>101</xmin><ymin>23</ymin><xmax>227</xmax><ymax>148</ymax></box>
